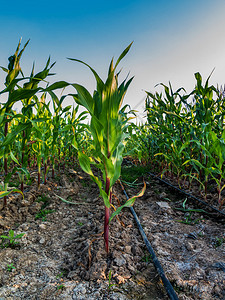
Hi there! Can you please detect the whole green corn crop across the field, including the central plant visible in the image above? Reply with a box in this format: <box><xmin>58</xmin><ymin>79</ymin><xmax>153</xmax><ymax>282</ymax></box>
<box><xmin>0</xmin><ymin>41</ymin><xmax>225</xmax><ymax>252</ymax></box>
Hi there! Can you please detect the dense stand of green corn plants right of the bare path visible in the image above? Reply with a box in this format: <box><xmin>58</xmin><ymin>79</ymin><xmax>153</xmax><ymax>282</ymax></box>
<box><xmin>142</xmin><ymin>73</ymin><xmax>225</xmax><ymax>207</ymax></box>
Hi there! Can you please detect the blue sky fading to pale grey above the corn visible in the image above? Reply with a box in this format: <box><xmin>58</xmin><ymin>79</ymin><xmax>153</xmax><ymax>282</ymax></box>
<box><xmin>0</xmin><ymin>0</ymin><xmax>225</xmax><ymax>120</ymax></box>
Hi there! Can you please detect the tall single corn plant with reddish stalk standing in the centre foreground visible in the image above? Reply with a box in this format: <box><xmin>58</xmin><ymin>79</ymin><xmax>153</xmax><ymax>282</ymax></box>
<box><xmin>70</xmin><ymin>44</ymin><xmax>145</xmax><ymax>253</ymax></box>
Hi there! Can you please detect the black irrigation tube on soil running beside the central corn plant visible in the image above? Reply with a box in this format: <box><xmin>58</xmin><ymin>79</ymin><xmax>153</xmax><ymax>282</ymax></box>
<box><xmin>119</xmin><ymin>181</ymin><xmax>178</xmax><ymax>300</ymax></box>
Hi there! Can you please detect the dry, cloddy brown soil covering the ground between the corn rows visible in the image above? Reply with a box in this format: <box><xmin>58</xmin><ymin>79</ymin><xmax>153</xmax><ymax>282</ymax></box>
<box><xmin>0</xmin><ymin>165</ymin><xmax>225</xmax><ymax>300</ymax></box>
